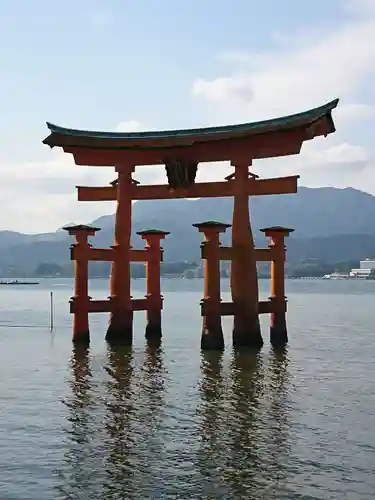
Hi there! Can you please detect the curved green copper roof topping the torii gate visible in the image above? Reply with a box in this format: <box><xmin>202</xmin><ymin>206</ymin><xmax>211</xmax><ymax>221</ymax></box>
<box><xmin>43</xmin><ymin>99</ymin><xmax>339</xmax><ymax>147</ymax></box>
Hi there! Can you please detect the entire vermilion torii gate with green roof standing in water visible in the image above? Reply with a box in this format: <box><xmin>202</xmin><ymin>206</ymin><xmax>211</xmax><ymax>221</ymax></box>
<box><xmin>43</xmin><ymin>99</ymin><xmax>338</xmax><ymax>348</ymax></box>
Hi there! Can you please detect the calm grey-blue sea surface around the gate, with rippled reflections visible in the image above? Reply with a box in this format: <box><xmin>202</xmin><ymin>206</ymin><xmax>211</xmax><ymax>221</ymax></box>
<box><xmin>0</xmin><ymin>280</ymin><xmax>375</xmax><ymax>500</ymax></box>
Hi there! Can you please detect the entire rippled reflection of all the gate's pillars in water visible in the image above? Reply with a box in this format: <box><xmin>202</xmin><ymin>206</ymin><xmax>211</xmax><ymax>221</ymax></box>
<box><xmin>59</xmin><ymin>345</ymin><xmax>290</xmax><ymax>500</ymax></box>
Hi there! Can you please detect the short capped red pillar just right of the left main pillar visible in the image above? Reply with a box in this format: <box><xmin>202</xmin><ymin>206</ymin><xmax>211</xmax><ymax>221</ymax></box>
<box><xmin>137</xmin><ymin>229</ymin><xmax>169</xmax><ymax>341</ymax></box>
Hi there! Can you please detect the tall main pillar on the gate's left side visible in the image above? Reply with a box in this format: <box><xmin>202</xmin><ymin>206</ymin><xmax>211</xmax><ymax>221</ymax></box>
<box><xmin>106</xmin><ymin>165</ymin><xmax>134</xmax><ymax>345</ymax></box>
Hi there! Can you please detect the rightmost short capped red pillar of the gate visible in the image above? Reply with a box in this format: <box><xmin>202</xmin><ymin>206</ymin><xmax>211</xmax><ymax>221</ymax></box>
<box><xmin>261</xmin><ymin>226</ymin><xmax>294</xmax><ymax>346</ymax></box>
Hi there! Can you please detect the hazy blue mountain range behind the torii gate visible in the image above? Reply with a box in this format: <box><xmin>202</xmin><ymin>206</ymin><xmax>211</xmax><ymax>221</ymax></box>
<box><xmin>0</xmin><ymin>187</ymin><xmax>375</xmax><ymax>270</ymax></box>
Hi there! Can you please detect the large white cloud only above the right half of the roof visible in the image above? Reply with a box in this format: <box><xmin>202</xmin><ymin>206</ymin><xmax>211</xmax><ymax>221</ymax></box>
<box><xmin>192</xmin><ymin>7</ymin><xmax>375</xmax><ymax>121</ymax></box>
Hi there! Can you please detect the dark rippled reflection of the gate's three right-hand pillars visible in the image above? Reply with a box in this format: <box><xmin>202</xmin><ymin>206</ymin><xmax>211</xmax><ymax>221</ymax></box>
<box><xmin>197</xmin><ymin>350</ymin><xmax>294</xmax><ymax>499</ymax></box>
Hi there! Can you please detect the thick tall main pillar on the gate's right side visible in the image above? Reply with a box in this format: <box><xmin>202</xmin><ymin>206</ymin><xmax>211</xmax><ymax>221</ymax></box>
<box><xmin>229</xmin><ymin>162</ymin><xmax>263</xmax><ymax>348</ymax></box>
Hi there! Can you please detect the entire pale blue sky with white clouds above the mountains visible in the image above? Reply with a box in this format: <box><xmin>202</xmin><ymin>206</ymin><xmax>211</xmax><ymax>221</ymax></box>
<box><xmin>0</xmin><ymin>0</ymin><xmax>375</xmax><ymax>233</ymax></box>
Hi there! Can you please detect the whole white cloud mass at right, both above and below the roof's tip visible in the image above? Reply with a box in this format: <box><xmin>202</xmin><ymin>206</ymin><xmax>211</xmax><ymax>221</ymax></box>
<box><xmin>192</xmin><ymin>0</ymin><xmax>375</xmax><ymax>193</ymax></box>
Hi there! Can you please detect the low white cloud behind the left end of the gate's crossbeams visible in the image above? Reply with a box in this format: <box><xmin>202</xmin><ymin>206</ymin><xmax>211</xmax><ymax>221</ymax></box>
<box><xmin>0</xmin><ymin>149</ymin><xmax>171</xmax><ymax>233</ymax></box>
